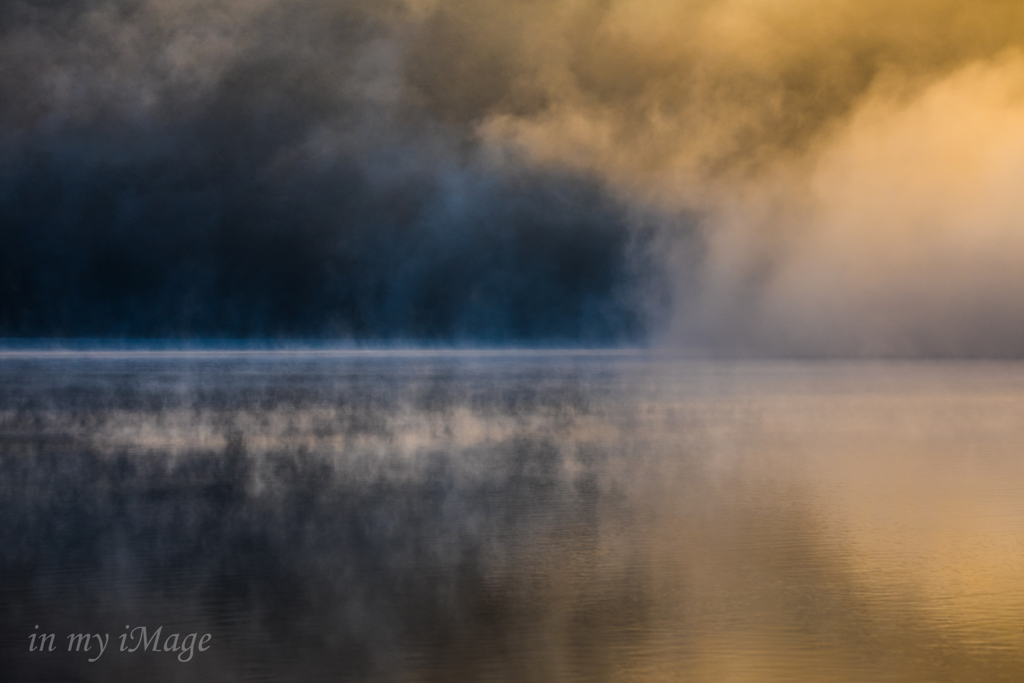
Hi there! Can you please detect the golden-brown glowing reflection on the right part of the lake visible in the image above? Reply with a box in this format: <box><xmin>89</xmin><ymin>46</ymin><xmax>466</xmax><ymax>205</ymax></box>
<box><xmin>409</xmin><ymin>364</ymin><xmax>1024</xmax><ymax>682</ymax></box>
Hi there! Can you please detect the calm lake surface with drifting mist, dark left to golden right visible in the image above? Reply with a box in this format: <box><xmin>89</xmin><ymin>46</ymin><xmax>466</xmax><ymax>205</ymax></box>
<box><xmin>0</xmin><ymin>351</ymin><xmax>1024</xmax><ymax>683</ymax></box>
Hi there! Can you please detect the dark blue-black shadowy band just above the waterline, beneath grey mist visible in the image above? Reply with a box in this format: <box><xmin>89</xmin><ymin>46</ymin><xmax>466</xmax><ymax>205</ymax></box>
<box><xmin>0</xmin><ymin>133</ymin><xmax>643</xmax><ymax>341</ymax></box>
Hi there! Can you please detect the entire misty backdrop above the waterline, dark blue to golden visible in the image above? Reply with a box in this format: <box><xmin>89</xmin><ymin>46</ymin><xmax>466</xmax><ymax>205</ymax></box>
<box><xmin>0</xmin><ymin>0</ymin><xmax>1024</xmax><ymax>357</ymax></box>
